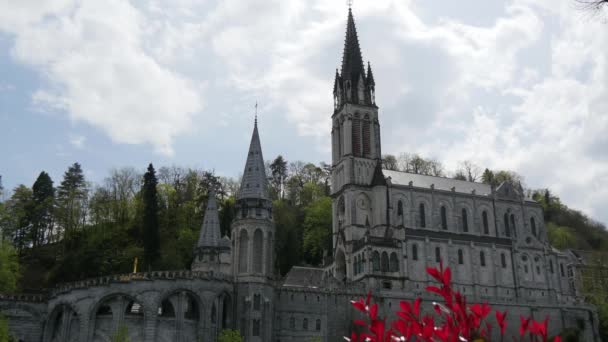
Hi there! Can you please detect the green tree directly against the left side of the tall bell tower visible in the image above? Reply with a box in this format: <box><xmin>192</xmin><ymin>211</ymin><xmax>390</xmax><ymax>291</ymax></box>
<box><xmin>303</xmin><ymin>197</ymin><xmax>332</xmax><ymax>265</ymax></box>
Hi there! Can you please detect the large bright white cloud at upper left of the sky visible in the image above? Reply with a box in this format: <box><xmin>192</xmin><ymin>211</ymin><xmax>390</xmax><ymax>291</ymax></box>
<box><xmin>0</xmin><ymin>0</ymin><xmax>203</xmax><ymax>154</ymax></box>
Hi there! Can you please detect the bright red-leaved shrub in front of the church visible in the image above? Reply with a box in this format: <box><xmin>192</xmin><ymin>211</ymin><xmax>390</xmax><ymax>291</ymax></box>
<box><xmin>345</xmin><ymin>263</ymin><xmax>561</xmax><ymax>342</ymax></box>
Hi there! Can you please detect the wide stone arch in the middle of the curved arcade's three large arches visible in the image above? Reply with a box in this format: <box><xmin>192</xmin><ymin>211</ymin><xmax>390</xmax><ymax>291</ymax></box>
<box><xmin>89</xmin><ymin>292</ymin><xmax>146</xmax><ymax>342</ymax></box>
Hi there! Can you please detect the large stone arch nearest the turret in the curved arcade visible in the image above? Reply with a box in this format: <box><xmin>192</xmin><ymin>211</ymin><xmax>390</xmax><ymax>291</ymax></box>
<box><xmin>155</xmin><ymin>288</ymin><xmax>203</xmax><ymax>342</ymax></box>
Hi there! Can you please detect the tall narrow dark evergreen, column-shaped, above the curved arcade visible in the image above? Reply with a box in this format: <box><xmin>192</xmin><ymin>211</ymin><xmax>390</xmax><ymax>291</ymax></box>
<box><xmin>142</xmin><ymin>163</ymin><xmax>160</xmax><ymax>269</ymax></box>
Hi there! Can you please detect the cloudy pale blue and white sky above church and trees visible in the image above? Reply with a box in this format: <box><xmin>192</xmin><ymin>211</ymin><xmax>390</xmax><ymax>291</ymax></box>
<box><xmin>0</xmin><ymin>0</ymin><xmax>608</xmax><ymax>223</ymax></box>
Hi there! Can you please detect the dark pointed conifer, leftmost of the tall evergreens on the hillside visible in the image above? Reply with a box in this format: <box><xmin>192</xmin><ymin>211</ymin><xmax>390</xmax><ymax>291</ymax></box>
<box><xmin>30</xmin><ymin>171</ymin><xmax>55</xmax><ymax>247</ymax></box>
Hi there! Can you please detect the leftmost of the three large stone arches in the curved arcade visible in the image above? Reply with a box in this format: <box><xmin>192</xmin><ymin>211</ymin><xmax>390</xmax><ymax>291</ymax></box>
<box><xmin>44</xmin><ymin>302</ymin><xmax>80</xmax><ymax>342</ymax></box>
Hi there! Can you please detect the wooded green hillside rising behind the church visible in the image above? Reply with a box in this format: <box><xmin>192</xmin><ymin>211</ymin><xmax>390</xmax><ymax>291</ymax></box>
<box><xmin>0</xmin><ymin>154</ymin><xmax>608</xmax><ymax>291</ymax></box>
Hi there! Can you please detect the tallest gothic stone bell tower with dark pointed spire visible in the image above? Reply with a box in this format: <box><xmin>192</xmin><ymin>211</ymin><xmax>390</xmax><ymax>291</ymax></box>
<box><xmin>331</xmin><ymin>8</ymin><xmax>387</xmax><ymax>280</ymax></box>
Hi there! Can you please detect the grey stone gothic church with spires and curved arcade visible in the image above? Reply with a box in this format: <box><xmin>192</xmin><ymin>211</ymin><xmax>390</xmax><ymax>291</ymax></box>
<box><xmin>0</xmin><ymin>9</ymin><xmax>600</xmax><ymax>342</ymax></box>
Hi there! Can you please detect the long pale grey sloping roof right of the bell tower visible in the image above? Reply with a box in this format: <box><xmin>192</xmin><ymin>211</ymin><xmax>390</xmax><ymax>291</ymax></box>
<box><xmin>382</xmin><ymin>170</ymin><xmax>492</xmax><ymax>196</ymax></box>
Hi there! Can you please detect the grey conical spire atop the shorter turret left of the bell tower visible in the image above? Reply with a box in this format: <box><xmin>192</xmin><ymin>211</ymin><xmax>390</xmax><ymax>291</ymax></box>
<box><xmin>238</xmin><ymin>117</ymin><xmax>270</xmax><ymax>200</ymax></box>
